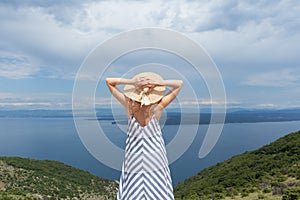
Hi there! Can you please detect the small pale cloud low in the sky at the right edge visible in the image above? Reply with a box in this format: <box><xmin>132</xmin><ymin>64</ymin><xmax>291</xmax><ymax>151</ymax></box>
<box><xmin>242</xmin><ymin>69</ymin><xmax>300</xmax><ymax>87</ymax></box>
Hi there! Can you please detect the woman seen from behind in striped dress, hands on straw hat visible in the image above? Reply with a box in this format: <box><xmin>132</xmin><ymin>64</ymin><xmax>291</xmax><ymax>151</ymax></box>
<box><xmin>106</xmin><ymin>72</ymin><xmax>182</xmax><ymax>200</ymax></box>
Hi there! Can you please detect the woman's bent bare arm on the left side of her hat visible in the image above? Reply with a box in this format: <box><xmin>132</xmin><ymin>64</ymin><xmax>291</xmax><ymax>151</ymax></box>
<box><xmin>106</xmin><ymin>78</ymin><xmax>135</xmax><ymax>109</ymax></box>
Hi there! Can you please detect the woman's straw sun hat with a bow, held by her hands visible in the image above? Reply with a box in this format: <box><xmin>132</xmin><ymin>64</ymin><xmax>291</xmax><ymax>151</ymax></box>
<box><xmin>123</xmin><ymin>72</ymin><xmax>166</xmax><ymax>106</ymax></box>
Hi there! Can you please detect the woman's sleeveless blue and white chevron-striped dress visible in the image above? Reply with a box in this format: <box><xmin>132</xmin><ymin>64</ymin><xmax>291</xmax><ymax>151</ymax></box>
<box><xmin>117</xmin><ymin>115</ymin><xmax>174</xmax><ymax>200</ymax></box>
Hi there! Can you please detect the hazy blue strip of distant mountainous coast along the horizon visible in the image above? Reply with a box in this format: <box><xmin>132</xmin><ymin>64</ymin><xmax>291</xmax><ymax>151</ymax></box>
<box><xmin>0</xmin><ymin>108</ymin><xmax>300</xmax><ymax>124</ymax></box>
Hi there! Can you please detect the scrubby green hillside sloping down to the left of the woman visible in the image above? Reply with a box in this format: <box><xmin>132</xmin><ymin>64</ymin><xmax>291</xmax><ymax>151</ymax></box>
<box><xmin>0</xmin><ymin>157</ymin><xmax>118</xmax><ymax>200</ymax></box>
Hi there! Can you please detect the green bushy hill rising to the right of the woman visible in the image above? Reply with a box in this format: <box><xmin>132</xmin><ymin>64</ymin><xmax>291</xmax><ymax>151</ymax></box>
<box><xmin>174</xmin><ymin>131</ymin><xmax>300</xmax><ymax>200</ymax></box>
